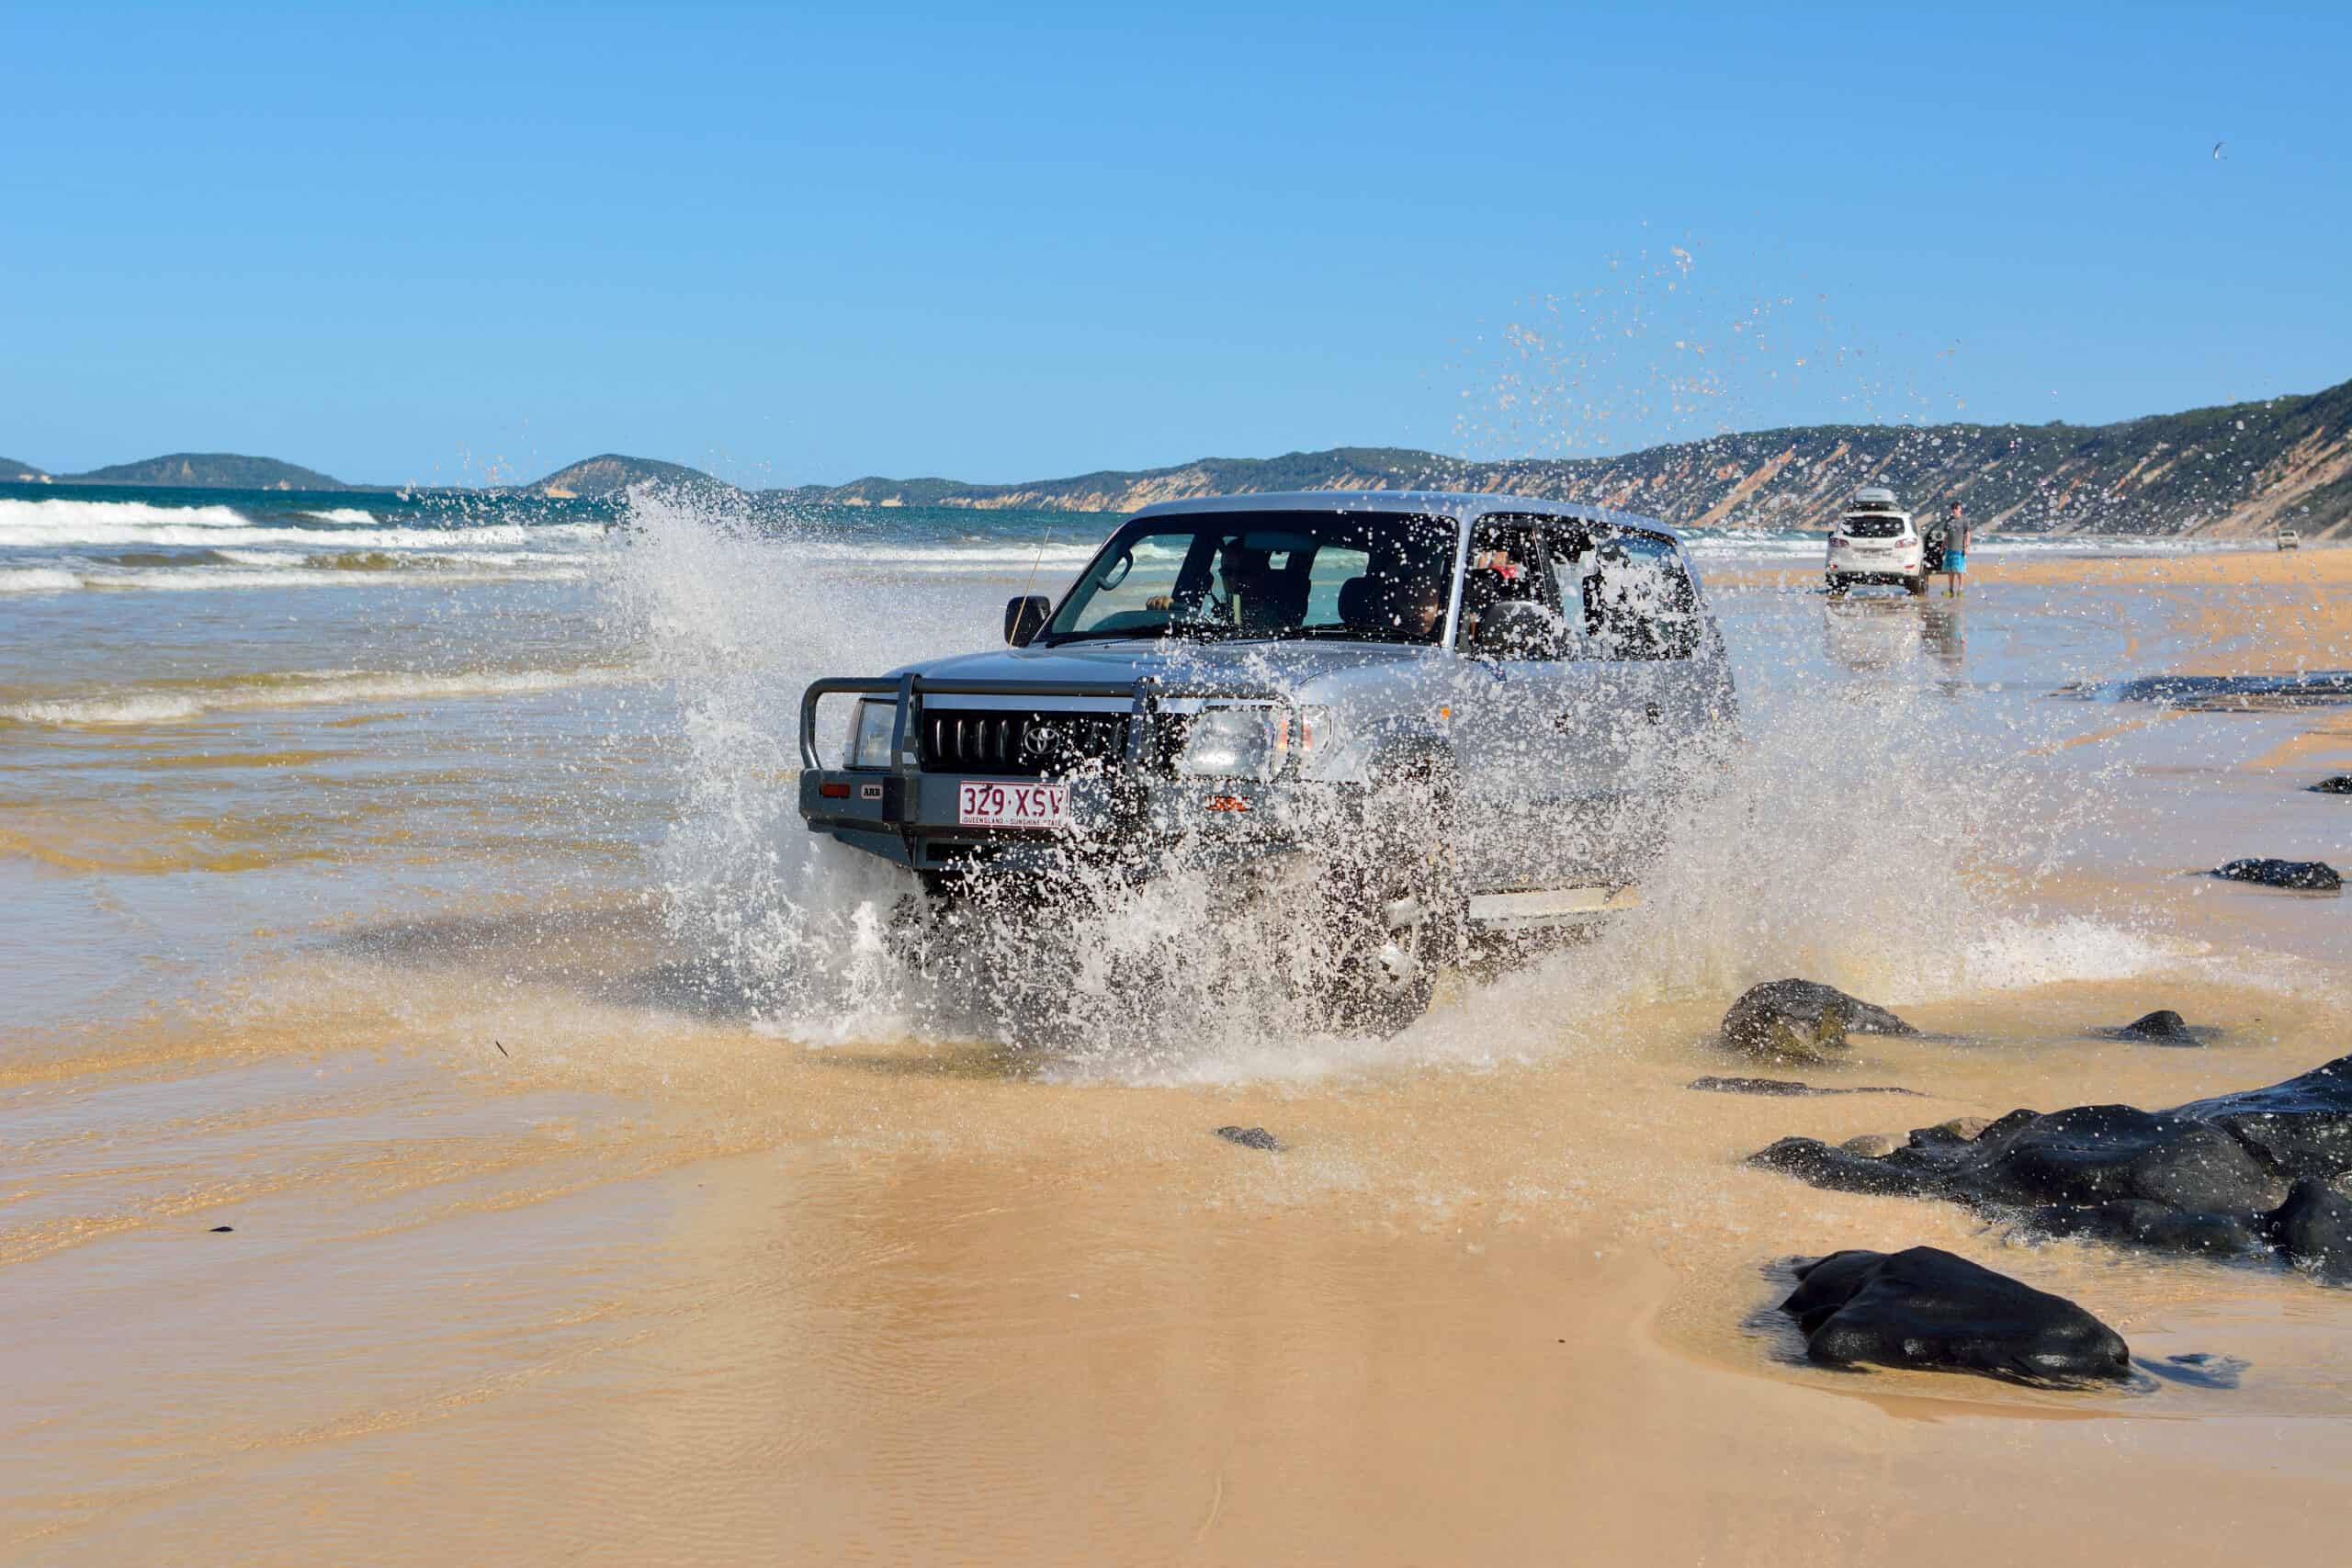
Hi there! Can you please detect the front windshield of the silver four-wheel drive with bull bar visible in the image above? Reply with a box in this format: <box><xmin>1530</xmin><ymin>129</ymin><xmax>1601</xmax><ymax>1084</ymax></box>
<box><xmin>1040</xmin><ymin>513</ymin><xmax>1456</xmax><ymax>644</ymax></box>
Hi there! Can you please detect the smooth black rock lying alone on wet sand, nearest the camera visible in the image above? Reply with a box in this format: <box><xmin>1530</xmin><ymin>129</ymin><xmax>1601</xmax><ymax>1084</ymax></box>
<box><xmin>1781</xmin><ymin>1246</ymin><xmax>2131</xmax><ymax>1384</ymax></box>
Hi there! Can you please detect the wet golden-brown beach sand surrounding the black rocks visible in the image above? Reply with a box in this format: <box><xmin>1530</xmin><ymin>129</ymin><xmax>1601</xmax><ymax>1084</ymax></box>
<box><xmin>0</xmin><ymin>536</ymin><xmax>2352</xmax><ymax>1563</ymax></box>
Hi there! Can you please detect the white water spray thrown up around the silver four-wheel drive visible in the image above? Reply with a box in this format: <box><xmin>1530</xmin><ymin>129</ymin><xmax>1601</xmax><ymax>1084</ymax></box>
<box><xmin>612</xmin><ymin>493</ymin><xmax>2159</xmax><ymax>1081</ymax></box>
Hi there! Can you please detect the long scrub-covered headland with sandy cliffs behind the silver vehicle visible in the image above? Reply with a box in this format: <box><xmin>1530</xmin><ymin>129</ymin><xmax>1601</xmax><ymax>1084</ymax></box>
<box><xmin>797</xmin><ymin>381</ymin><xmax>2352</xmax><ymax>536</ymax></box>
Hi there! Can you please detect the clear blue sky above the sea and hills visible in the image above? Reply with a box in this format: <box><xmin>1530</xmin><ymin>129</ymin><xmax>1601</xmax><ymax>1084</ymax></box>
<box><xmin>0</xmin><ymin>3</ymin><xmax>2352</xmax><ymax>484</ymax></box>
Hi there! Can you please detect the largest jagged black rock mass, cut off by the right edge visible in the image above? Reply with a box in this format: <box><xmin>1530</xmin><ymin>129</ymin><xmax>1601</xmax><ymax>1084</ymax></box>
<box><xmin>1750</xmin><ymin>1055</ymin><xmax>2352</xmax><ymax>1283</ymax></box>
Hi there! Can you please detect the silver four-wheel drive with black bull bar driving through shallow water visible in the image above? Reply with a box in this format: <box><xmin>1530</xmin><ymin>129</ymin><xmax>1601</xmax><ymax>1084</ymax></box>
<box><xmin>799</xmin><ymin>491</ymin><xmax>1736</xmax><ymax>1027</ymax></box>
